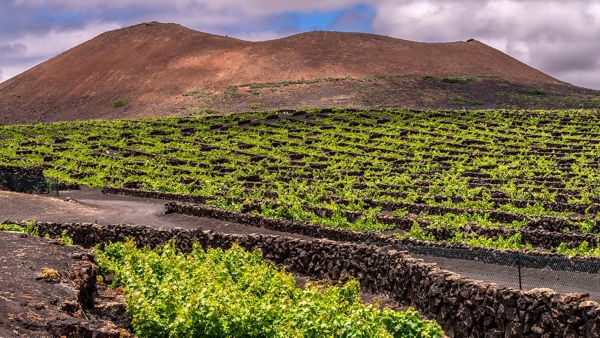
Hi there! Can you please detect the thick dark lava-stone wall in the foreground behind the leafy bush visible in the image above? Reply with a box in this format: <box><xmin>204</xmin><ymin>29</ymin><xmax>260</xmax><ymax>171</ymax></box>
<box><xmin>12</xmin><ymin>223</ymin><xmax>600</xmax><ymax>337</ymax></box>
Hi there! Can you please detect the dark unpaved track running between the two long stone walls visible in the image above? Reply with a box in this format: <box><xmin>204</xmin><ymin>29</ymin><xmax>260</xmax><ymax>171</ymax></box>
<box><xmin>0</xmin><ymin>190</ymin><xmax>600</xmax><ymax>300</ymax></box>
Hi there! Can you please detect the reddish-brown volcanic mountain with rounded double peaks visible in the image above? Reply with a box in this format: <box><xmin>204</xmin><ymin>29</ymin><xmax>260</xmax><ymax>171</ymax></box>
<box><xmin>0</xmin><ymin>22</ymin><xmax>598</xmax><ymax>124</ymax></box>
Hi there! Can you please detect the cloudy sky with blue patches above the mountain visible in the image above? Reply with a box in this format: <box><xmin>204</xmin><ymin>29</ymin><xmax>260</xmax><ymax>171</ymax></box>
<box><xmin>0</xmin><ymin>0</ymin><xmax>600</xmax><ymax>89</ymax></box>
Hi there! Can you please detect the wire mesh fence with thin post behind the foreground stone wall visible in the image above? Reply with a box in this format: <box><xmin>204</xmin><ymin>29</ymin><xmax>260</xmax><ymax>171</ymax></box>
<box><xmin>397</xmin><ymin>244</ymin><xmax>600</xmax><ymax>300</ymax></box>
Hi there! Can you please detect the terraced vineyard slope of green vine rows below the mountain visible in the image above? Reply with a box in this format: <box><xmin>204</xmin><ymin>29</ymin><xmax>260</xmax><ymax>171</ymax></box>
<box><xmin>0</xmin><ymin>110</ymin><xmax>600</xmax><ymax>255</ymax></box>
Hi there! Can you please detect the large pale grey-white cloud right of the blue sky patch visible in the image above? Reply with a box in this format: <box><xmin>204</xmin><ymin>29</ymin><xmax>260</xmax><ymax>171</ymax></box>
<box><xmin>373</xmin><ymin>0</ymin><xmax>600</xmax><ymax>88</ymax></box>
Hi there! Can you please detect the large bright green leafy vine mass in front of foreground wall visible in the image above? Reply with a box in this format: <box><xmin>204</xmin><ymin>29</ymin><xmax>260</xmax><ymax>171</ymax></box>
<box><xmin>98</xmin><ymin>242</ymin><xmax>443</xmax><ymax>337</ymax></box>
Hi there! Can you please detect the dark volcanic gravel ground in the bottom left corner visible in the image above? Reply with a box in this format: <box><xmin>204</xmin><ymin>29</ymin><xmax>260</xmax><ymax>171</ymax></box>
<box><xmin>0</xmin><ymin>231</ymin><xmax>125</xmax><ymax>338</ymax></box>
